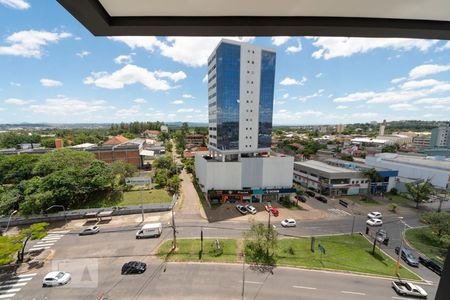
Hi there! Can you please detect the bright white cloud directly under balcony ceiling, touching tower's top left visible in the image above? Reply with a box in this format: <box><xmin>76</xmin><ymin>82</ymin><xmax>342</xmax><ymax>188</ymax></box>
<box><xmin>109</xmin><ymin>36</ymin><xmax>254</xmax><ymax>67</ymax></box>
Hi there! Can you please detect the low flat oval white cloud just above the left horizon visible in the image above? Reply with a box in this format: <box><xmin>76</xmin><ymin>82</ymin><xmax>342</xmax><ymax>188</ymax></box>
<box><xmin>27</xmin><ymin>95</ymin><xmax>108</xmax><ymax>116</ymax></box>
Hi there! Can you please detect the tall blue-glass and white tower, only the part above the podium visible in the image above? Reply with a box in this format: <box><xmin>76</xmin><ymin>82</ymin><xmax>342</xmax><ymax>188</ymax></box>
<box><xmin>208</xmin><ymin>40</ymin><xmax>276</xmax><ymax>156</ymax></box>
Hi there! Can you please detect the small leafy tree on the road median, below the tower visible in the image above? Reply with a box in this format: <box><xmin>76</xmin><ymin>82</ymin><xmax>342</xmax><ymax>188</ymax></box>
<box><xmin>244</xmin><ymin>223</ymin><xmax>278</xmax><ymax>265</ymax></box>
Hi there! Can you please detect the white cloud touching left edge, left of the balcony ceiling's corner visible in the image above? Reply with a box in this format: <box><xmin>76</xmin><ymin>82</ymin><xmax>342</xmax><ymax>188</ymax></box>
<box><xmin>0</xmin><ymin>30</ymin><xmax>71</xmax><ymax>58</ymax></box>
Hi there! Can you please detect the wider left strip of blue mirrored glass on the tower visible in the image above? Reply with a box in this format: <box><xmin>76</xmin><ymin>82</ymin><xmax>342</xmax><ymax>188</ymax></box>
<box><xmin>216</xmin><ymin>43</ymin><xmax>241</xmax><ymax>150</ymax></box>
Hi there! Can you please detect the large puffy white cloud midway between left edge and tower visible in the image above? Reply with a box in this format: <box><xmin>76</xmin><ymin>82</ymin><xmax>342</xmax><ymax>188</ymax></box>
<box><xmin>83</xmin><ymin>65</ymin><xmax>170</xmax><ymax>91</ymax></box>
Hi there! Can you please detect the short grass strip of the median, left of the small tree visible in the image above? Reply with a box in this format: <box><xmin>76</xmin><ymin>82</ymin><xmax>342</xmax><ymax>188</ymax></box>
<box><xmin>158</xmin><ymin>239</ymin><xmax>237</xmax><ymax>262</ymax></box>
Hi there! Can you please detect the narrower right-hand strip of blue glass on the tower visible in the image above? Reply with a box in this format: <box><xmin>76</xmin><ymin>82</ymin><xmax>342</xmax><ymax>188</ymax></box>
<box><xmin>258</xmin><ymin>50</ymin><xmax>276</xmax><ymax>148</ymax></box>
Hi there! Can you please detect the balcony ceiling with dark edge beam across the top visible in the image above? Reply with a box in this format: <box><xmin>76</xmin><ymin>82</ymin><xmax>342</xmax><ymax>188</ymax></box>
<box><xmin>57</xmin><ymin>0</ymin><xmax>450</xmax><ymax>40</ymax></box>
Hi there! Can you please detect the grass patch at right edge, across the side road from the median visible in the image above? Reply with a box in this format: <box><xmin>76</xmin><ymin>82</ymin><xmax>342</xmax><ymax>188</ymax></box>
<box><xmin>405</xmin><ymin>227</ymin><xmax>447</xmax><ymax>265</ymax></box>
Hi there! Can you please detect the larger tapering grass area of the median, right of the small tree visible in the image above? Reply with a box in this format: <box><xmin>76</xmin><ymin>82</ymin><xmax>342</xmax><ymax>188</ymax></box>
<box><xmin>277</xmin><ymin>235</ymin><xmax>419</xmax><ymax>279</ymax></box>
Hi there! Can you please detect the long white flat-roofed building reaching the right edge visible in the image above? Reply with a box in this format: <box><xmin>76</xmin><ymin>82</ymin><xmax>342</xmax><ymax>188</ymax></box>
<box><xmin>366</xmin><ymin>153</ymin><xmax>450</xmax><ymax>191</ymax></box>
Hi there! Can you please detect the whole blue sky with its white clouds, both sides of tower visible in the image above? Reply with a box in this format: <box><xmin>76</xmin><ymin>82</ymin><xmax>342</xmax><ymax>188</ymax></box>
<box><xmin>0</xmin><ymin>0</ymin><xmax>450</xmax><ymax>124</ymax></box>
